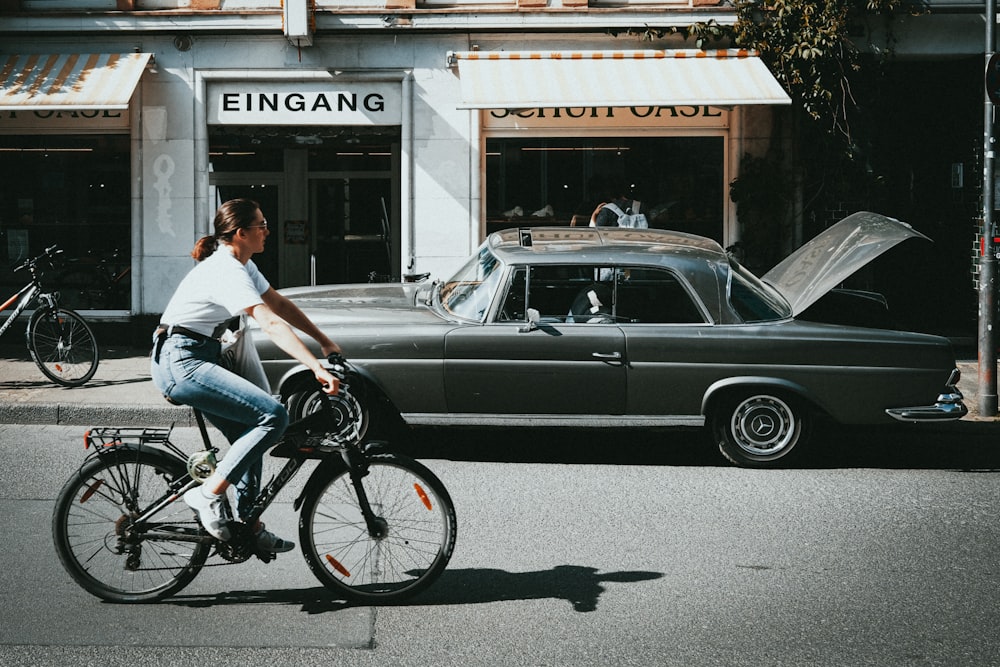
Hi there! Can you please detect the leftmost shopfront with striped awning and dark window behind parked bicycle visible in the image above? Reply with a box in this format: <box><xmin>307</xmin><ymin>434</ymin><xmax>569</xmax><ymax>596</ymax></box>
<box><xmin>0</xmin><ymin>53</ymin><xmax>150</xmax><ymax>316</ymax></box>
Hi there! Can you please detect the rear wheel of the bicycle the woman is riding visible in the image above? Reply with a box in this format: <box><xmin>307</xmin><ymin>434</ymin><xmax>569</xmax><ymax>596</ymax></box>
<box><xmin>52</xmin><ymin>449</ymin><xmax>211</xmax><ymax>603</ymax></box>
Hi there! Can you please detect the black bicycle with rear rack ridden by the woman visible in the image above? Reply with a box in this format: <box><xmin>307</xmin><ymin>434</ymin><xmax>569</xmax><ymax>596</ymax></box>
<box><xmin>52</xmin><ymin>355</ymin><xmax>457</xmax><ymax>604</ymax></box>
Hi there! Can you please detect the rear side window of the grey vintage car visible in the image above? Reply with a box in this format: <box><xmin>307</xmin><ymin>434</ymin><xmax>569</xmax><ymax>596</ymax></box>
<box><xmin>615</xmin><ymin>267</ymin><xmax>705</xmax><ymax>324</ymax></box>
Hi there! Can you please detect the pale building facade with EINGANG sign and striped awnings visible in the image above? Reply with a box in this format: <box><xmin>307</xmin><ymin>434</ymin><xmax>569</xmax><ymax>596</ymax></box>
<box><xmin>0</xmin><ymin>0</ymin><xmax>982</xmax><ymax>340</ymax></box>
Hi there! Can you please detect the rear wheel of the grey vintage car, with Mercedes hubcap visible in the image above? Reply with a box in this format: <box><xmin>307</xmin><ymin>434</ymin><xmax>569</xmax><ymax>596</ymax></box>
<box><xmin>709</xmin><ymin>392</ymin><xmax>810</xmax><ymax>468</ymax></box>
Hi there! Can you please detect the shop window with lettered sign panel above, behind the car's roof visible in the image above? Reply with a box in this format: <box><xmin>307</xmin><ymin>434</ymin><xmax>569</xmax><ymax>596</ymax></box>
<box><xmin>483</xmin><ymin>106</ymin><xmax>730</xmax><ymax>243</ymax></box>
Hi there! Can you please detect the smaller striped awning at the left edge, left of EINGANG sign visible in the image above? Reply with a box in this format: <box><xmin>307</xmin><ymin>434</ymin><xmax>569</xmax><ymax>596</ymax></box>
<box><xmin>0</xmin><ymin>53</ymin><xmax>151</xmax><ymax>111</ymax></box>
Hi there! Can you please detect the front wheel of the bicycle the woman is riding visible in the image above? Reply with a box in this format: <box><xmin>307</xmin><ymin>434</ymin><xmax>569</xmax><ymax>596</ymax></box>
<box><xmin>299</xmin><ymin>453</ymin><xmax>457</xmax><ymax>604</ymax></box>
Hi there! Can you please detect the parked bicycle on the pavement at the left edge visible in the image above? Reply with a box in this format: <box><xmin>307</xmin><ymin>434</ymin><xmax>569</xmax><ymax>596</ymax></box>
<box><xmin>0</xmin><ymin>246</ymin><xmax>100</xmax><ymax>387</ymax></box>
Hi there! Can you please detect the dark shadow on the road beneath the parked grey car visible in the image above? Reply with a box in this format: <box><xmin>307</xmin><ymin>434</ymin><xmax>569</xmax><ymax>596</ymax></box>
<box><xmin>393</xmin><ymin>420</ymin><xmax>1000</xmax><ymax>472</ymax></box>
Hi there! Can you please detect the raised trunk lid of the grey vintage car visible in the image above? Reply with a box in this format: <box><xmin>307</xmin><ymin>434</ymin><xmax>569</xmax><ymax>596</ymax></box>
<box><xmin>763</xmin><ymin>211</ymin><xmax>930</xmax><ymax>315</ymax></box>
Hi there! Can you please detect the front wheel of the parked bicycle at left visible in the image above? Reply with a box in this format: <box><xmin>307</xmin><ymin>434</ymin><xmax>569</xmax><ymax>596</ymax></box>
<box><xmin>25</xmin><ymin>308</ymin><xmax>100</xmax><ymax>387</ymax></box>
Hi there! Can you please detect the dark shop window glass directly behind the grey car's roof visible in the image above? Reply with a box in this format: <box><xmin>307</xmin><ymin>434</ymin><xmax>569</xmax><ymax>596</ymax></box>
<box><xmin>486</xmin><ymin>136</ymin><xmax>726</xmax><ymax>243</ymax></box>
